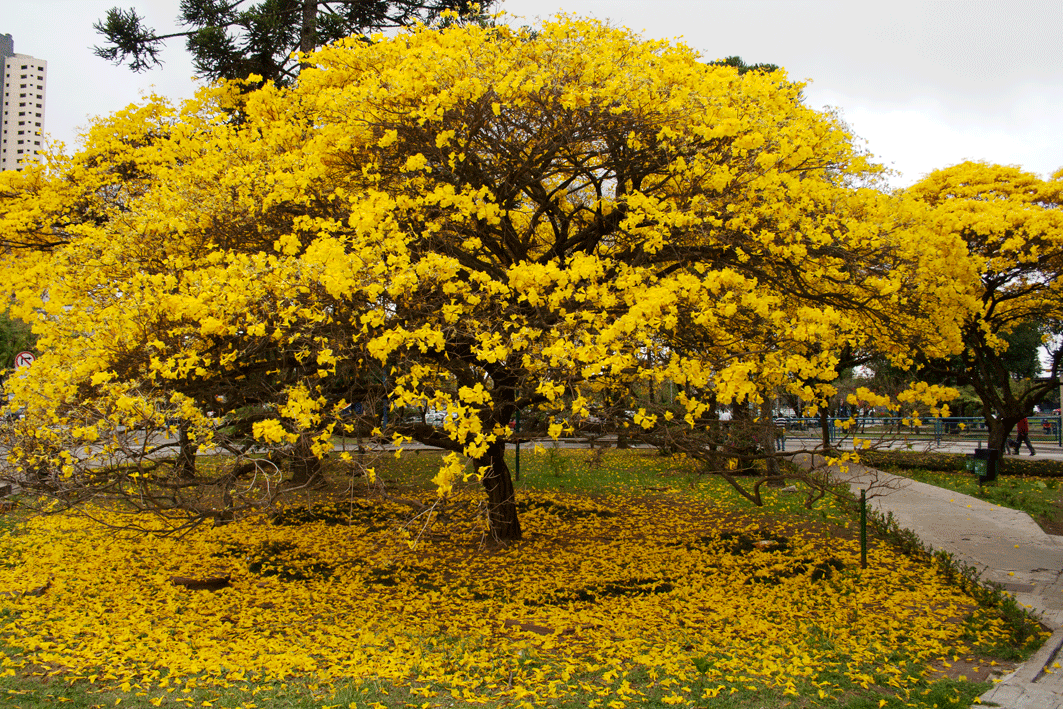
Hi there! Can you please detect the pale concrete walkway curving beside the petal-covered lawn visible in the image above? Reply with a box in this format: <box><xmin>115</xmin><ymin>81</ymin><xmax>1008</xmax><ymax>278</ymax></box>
<box><xmin>845</xmin><ymin>463</ymin><xmax>1063</xmax><ymax>709</ymax></box>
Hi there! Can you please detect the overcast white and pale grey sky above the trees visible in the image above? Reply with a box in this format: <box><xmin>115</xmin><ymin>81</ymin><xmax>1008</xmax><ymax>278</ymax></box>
<box><xmin>0</xmin><ymin>0</ymin><xmax>1063</xmax><ymax>186</ymax></box>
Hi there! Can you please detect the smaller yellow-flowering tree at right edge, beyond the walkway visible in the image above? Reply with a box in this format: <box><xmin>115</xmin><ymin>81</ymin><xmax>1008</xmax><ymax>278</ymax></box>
<box><xmin>907</xmin><ymin>163</ymin><xmax>1063</xmax><ymax>452</ymax></box>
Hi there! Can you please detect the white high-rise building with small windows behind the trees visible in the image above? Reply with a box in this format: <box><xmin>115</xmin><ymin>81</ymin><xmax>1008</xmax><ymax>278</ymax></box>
<box><xmin>0</xmin><ymin>34</ymin><xmax>48</xmax><ymax>170</ymax></box>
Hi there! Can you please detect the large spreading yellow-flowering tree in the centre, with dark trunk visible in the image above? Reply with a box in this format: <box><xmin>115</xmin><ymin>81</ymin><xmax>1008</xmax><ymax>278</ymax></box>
<box><xmin>0</xmin><ymin>18</ymin><xmax>966</xmax><ymax>540</ymax></box>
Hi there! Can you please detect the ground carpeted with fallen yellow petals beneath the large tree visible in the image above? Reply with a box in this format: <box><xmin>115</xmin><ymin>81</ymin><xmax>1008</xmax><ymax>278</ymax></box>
<box><xmin>0</xmin><ymin>453</ymin><xmax>1045</xmax><ymax>708</ymax></box>
